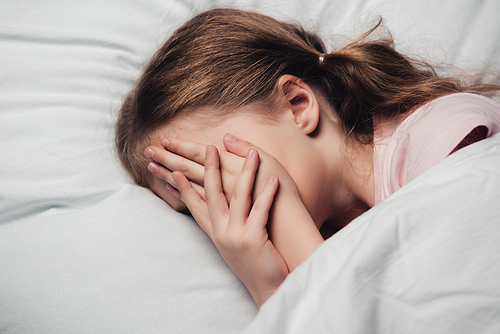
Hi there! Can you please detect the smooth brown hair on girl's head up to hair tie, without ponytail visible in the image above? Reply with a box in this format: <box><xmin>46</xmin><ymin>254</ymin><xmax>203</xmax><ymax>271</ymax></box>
<box><xmin>116</xmin><ymin>9</ymin><xmax>325</xmax><ymax>186</ymax></box>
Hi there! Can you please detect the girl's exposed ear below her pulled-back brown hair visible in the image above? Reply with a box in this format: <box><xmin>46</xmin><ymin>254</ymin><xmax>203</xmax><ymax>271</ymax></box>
<box><xmin>278</xmin><ymin>74</ymin><xmax>319</xmax><ymax>134</ymax></box>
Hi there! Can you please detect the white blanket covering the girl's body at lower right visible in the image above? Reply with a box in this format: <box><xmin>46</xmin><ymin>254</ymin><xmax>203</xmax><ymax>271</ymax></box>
<box><xmin>245</xmin><ymin>135</ymin><xmax>500</xmax><ymax>334</ymax></box>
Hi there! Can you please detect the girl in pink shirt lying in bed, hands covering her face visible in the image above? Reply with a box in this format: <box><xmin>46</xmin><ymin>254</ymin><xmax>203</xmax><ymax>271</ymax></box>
<box><xmin>116</xmin><ymin>9</ymin><xmax>500</xmax><ymax>305</ymax></box>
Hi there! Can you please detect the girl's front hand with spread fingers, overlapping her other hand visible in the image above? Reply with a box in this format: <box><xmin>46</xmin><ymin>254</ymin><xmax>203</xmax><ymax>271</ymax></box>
<box><xmin>172</xmin><ymin>146</ymin><xmax>288</xmax><ymax>306</ymax></box>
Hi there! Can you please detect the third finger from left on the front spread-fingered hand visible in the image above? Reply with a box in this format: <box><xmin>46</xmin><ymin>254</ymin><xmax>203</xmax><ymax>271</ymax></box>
<box><xmin>229</xmin><ymin>150</ymin><xmax>259</xmax><ymax>228</ymax></box>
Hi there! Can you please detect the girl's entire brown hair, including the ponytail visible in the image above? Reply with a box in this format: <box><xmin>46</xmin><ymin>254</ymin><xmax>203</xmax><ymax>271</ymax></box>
<box><xmin>115</xmin><ymin>9</ymin><xmax>500</xmax><ymax>187</ymax></box>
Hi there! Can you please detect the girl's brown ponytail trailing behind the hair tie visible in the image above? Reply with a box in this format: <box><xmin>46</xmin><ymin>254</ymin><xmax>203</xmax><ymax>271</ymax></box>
<box><xmin>315</xmin><ymin>20</ymin><xmax>500</xmax><ymax>143</ymax></box>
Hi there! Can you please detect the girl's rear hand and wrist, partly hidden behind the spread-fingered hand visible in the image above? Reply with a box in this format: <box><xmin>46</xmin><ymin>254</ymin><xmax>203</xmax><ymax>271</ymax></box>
<box><xmin>148</xmin><ymin>134</ymin><xmax>323</xmax><ymax>271</ymax></box>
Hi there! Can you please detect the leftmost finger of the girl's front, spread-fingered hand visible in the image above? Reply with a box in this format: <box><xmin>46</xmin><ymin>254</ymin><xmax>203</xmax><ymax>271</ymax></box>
<box><xmin>172</xmin><ymin>172</ymin><xmax>213</xmax><ymax>235</ymax></box>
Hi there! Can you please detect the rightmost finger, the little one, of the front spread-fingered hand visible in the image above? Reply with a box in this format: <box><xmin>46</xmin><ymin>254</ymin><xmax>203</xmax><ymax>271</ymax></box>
<box><xmin>247</xmin><ymin>175</ymin><xmax>279</xmax><ymax>232</ymax></box>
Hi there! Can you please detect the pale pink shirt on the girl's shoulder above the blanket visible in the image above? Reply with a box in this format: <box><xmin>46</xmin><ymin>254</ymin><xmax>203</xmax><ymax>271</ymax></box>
<box><xmin>374</xmin><ymin>93</ymin><xmax>500</xmax><ymax>204</ymax></box>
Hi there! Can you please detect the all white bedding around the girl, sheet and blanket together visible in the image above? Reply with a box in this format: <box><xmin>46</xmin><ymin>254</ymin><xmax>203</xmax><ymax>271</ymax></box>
<box><xmin>0</xmin><ymin>0</ymin><xmax>500</xmax><ymax>333</ymax></box>
